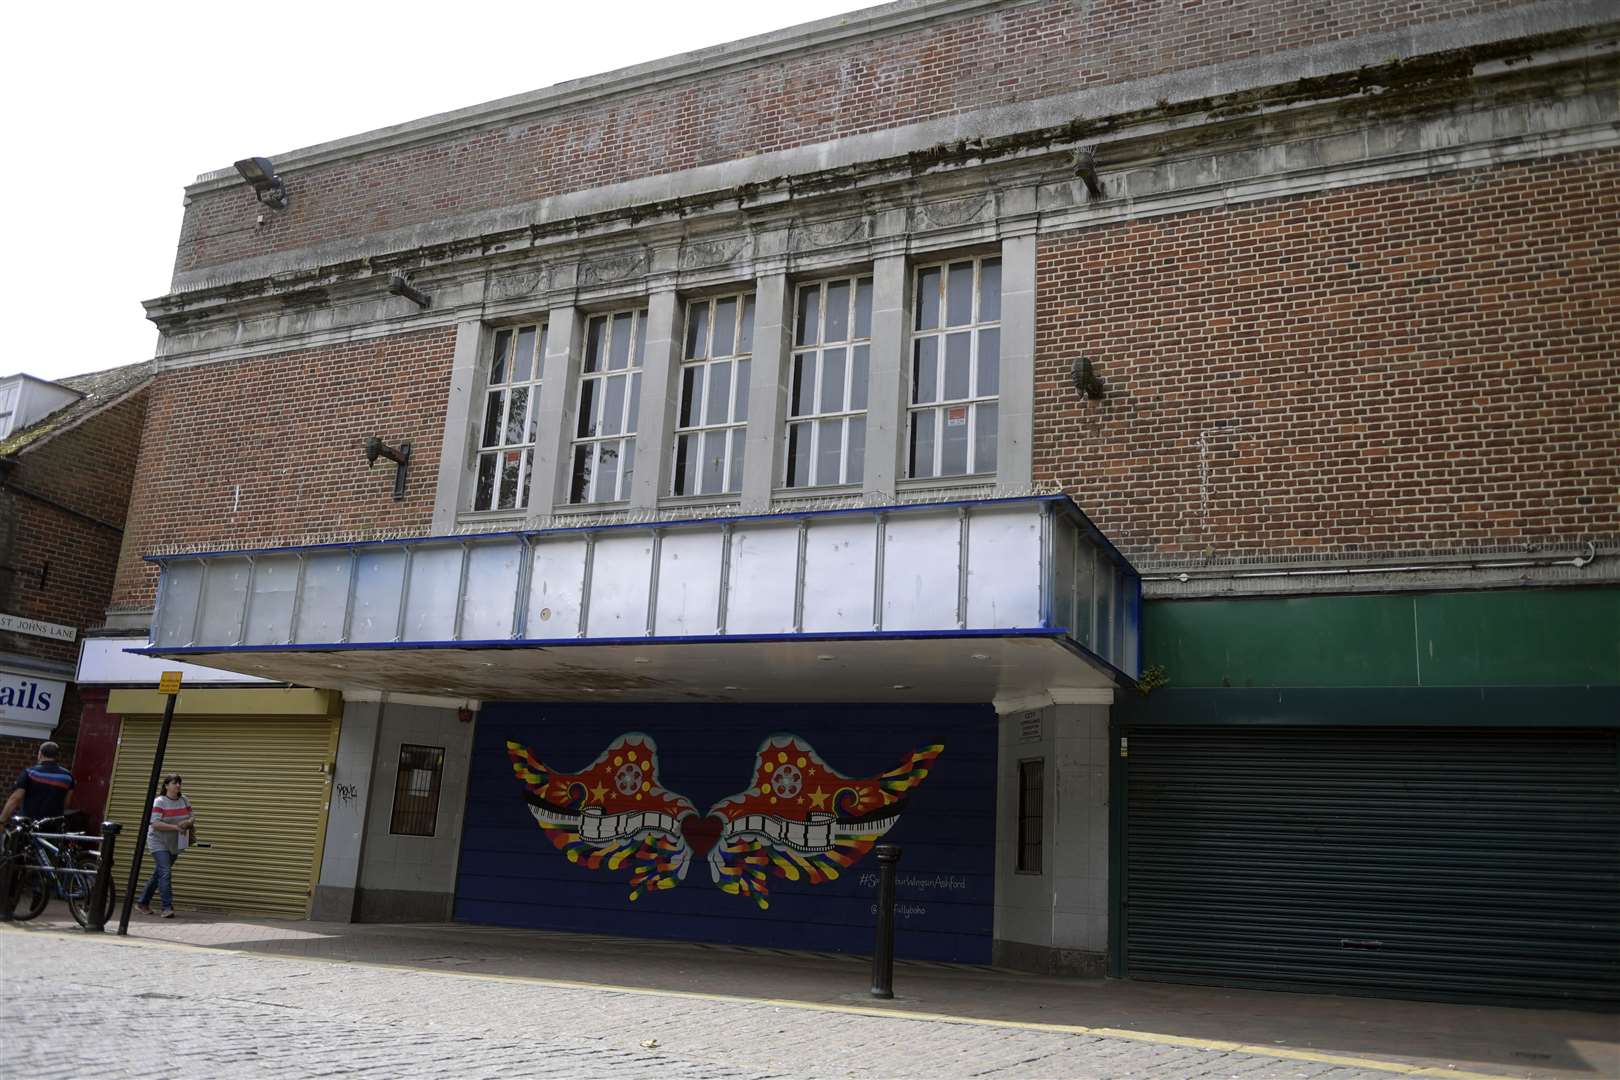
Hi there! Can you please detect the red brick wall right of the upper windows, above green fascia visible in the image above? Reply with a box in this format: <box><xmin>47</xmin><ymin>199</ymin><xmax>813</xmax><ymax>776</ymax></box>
<box><xmin>1035</xmin><ymin>152</ymin><xmax>1620</xmax><ymax>555</ymax></box>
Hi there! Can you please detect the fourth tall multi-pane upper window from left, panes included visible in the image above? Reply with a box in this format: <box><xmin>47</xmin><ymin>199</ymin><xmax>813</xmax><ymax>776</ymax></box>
<box><xmin>784</xmin><ymin>277</ymin><xmax>872</xmax><ymax>487</ymax></box>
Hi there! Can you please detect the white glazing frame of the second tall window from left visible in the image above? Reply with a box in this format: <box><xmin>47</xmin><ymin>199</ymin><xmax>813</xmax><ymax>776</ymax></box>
<box><xmin>569</xmin><ymin>304</ymin><xmax>646</xmax><ymax>505</ymax></box>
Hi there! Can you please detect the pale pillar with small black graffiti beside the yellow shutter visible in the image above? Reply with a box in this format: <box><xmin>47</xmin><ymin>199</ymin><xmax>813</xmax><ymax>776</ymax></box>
<box><xmin>309</xmin><ymin>701</ymin><xmax>382</xmax><ymax>923</ymax></box>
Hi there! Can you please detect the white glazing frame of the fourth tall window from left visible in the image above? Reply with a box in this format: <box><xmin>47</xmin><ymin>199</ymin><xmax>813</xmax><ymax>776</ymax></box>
<box><xmin>781</xmin><ymin>272</ymin><xmax>873</xmax><ymax>491</ymax></box>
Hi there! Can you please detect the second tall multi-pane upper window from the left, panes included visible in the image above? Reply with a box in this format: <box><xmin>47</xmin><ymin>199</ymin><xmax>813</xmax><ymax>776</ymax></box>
<box><xmin>569</xmin><ymin>308</ymin><xmax>646</xmax><ymax>502</ymax></box>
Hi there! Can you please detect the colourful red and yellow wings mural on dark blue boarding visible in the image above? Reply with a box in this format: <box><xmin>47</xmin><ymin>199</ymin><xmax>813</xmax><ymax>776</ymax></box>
<box><xmin>507</xmin><ymin>732</ymin><xmax>944</xmax><ymax>910</ymax></box>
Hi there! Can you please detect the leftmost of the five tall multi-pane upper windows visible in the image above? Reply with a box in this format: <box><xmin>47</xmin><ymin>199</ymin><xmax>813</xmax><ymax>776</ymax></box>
<box><xmin>473</xmin><ymin>324</ymin><xmax>546</xmax><ymax>510</ymax></box>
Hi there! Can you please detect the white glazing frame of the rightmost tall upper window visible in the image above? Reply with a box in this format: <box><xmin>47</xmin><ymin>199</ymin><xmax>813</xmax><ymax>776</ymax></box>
<box><xmin>906</xmin><ymin>253</ymin><xmax>1004</xmax><ymax>479</ymax></box>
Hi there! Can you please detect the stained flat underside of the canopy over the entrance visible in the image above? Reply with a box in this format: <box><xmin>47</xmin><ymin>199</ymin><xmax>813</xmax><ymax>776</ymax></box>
<box><xmin>145</xmin><ymin>635</ymin><xmax>1121</xmax><ymax>703</ymax></box>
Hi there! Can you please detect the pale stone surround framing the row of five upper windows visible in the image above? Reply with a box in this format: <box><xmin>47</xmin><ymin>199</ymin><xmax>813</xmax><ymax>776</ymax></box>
<box><xmin>434</xmin><ymin>230</ymin><xmax>1035</xmax><ymax>531</ymax></box>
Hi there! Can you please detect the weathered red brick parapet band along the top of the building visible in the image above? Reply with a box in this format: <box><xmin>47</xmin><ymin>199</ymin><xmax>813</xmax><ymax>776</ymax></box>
<box><xmin>175</xmin><ymin>0</ymin><xmax>1521</xmax><ymax>270</ymax></box>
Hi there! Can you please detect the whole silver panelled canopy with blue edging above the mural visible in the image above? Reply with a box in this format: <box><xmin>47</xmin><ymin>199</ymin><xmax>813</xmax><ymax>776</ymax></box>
<box><xmin>139</xmin><ymin>495</ymin><xmax>1140</xmax><ymax>701</ymax></box>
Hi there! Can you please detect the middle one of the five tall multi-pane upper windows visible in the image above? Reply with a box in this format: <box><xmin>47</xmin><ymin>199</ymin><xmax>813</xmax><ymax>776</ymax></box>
<box><xmin>671</xmin><ymin>293</ymin><xmax>753</xmax><ymax>495</ymax></box>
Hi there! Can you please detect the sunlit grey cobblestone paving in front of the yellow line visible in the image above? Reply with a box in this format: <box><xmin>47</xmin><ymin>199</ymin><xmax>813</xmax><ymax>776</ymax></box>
<box><xmin>9</xmin><ymin>929</ymin><xmax>1432</xmax><ymax>1080</ymax></box>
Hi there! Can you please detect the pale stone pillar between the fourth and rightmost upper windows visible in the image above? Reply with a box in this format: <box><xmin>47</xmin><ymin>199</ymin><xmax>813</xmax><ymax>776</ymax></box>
<box><xmin>862</xmin><ymin>254</ymin><xmax>910</xmax><ymax>502</ymax></box>
